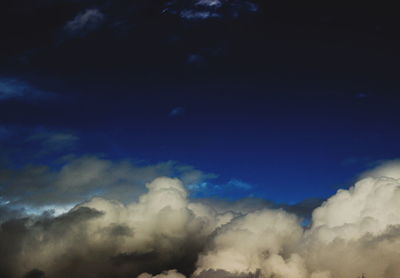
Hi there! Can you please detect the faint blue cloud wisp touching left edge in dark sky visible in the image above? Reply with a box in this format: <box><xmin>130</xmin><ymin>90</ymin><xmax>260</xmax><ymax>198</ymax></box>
<box><xmin>0</xmin><ymin>78</ymin><xmax>51</xmax><ymax>101</ymax></box>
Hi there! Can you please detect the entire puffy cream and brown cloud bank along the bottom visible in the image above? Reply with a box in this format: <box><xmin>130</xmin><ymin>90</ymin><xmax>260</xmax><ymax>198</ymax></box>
<box><xmin>0</xmin><ymin>162</ymin><xmax>400</xmax><ymax>278</ymax></box>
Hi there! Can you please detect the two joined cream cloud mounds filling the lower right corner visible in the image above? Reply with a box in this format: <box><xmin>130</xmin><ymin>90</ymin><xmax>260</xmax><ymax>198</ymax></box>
<box><xmin>195</xmin><ymin>162</ymin><xmax>400</xmax><ymax>278</ymax></box>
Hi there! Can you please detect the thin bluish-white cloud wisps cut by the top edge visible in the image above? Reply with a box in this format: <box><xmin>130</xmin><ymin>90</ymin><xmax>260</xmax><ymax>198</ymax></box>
<box><xmin>164</xmin><ymin>0</ymin><xmax>259</xmax><ymax>21</ymax></box>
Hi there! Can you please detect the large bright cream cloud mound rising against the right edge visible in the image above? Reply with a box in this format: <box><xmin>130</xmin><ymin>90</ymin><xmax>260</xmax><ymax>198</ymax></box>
<box><xmin>301</xmin><ymin>162</ymin><xmax>400</xmax><ymax>278</ymax></box>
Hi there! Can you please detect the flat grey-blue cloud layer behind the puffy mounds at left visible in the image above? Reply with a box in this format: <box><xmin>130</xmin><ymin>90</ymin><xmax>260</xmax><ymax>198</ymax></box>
<box><xmin>0</xmin><ymin>155</ymin><xmax>215</xmax><ymax>209</ymax></box>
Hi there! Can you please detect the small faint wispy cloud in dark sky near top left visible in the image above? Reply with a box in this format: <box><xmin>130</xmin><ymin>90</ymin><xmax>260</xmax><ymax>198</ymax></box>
<box><xmin>64</xmin><ymin>8</ymin><xmax>105</xmax><ymax>36</ymax></box>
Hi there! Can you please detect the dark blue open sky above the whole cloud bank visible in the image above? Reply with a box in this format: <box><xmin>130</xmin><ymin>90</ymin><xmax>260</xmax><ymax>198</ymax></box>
<box><xmin>0</xmin><ymin>0</ymin><xmax>400</xmax><ymax>207</ymax></box>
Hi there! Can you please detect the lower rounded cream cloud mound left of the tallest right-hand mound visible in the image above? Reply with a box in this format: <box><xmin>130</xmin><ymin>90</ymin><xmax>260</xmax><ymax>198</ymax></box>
<box><xmin>196</xmin><ymin>210</ymin><xmax>302</xmax><ymax>274</ymax></box>
